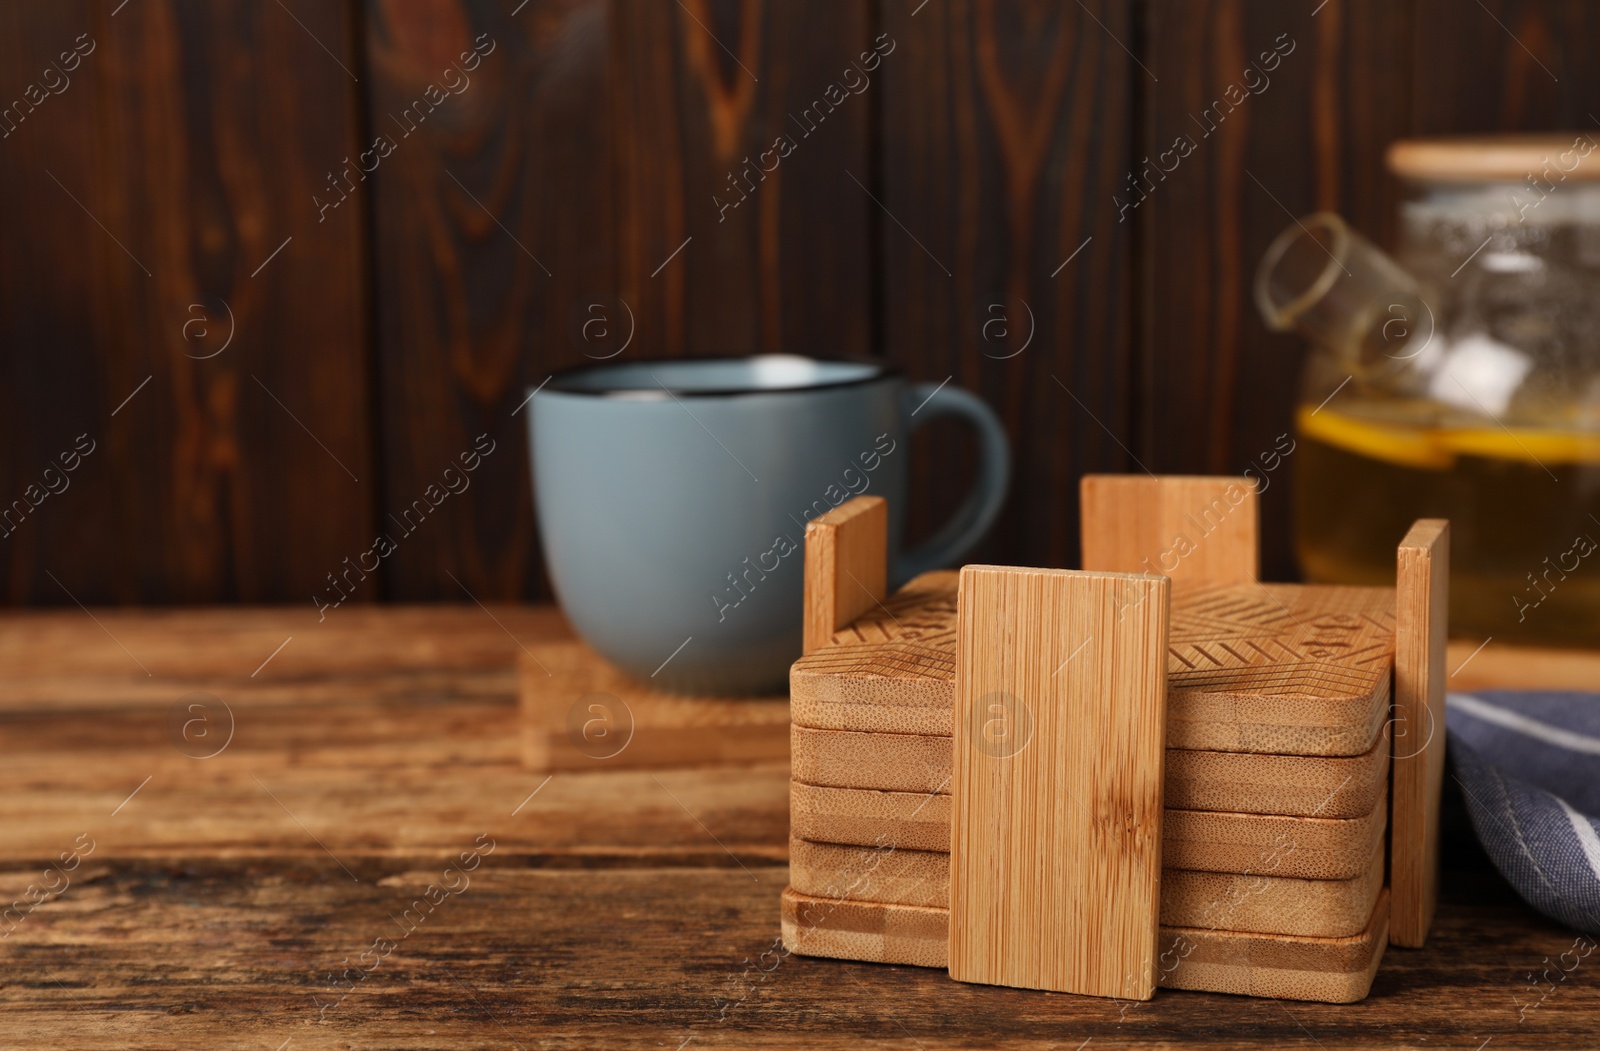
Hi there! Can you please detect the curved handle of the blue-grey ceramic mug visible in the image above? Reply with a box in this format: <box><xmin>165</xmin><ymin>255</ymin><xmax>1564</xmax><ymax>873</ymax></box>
<box><xmin>890</xmin><ymin>384</ymin><xmax>1011</xmax><ymax>587</ymax></box>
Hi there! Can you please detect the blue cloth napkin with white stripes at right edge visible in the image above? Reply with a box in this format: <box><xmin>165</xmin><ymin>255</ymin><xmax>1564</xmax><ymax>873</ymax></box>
<box><xmin>1445</xmin><ymin>689</ymin><xmax>1600</xmax><ymax>933</ymax></box>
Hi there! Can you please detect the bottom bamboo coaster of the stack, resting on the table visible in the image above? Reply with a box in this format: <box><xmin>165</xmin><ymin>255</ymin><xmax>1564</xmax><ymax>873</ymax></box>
<box><xmin>781</xmin><ymin>888</ymin><xmax>1389</xmax><ymax>1003</ymax></box>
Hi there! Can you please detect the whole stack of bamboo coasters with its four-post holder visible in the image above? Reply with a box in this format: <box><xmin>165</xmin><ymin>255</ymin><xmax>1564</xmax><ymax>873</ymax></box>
<box><xmin>782</xmin><ymin>477</ymin><xmax>1443</xmax><ymax>1003</ymax></box>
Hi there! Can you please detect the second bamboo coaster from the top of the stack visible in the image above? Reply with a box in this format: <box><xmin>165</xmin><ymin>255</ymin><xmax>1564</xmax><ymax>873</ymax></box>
<box><xmin>790</xmin><ymin>726</ymin><xmax>1389</xmax><ymax>817</ymax></box>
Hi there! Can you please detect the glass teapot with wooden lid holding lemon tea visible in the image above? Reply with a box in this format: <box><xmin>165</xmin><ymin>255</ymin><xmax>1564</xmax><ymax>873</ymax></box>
<box><xmin>1256</xmin><ymin>133</ymin><xmax>1600</xmax><ymax>645</ymax></box>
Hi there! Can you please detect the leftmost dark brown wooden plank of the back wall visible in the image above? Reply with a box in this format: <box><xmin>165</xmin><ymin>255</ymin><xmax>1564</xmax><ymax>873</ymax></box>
<box><xmin>0</xmin><ymin>0</ymin><xmax>378</xmax><ymax>606</ymax></box>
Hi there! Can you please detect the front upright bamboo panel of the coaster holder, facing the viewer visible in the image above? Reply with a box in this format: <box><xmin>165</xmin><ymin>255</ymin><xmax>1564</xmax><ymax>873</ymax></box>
<box><xmin>950</xmin><ymin>566</ymin><xmax>1170</xmax><ymax>1000</ymax></box>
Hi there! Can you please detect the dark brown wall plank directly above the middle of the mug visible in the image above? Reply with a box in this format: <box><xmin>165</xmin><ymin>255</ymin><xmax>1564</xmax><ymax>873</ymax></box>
<box><xmin>608</xmin><ymin>0</ymin><xmax>870</xmax><ymax>357</ymax></box>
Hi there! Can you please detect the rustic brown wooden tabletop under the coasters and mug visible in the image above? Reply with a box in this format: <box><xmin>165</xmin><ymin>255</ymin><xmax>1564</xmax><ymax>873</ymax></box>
<box><xmin>0</xmin><ymin>606</ymin><xmax>1600</xmax><ymax>1051</ymax></box>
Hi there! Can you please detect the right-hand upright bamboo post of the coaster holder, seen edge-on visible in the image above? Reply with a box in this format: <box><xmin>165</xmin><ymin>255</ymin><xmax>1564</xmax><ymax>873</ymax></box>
<box><xmin>1389</xmin><ymin>518</ymin><xmax>1450</xmax><ymax>949</ymax></box>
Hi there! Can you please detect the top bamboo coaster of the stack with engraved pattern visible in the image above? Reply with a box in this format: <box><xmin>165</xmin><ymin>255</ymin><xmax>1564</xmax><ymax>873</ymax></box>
<box><xmin>789</xmin><ymin>573</ymin><xmax>1395</xmax><ymax>757</ymax></box>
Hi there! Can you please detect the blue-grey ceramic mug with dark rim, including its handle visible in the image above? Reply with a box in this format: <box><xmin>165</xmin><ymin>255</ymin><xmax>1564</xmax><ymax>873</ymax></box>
<box><xmin>528</xmin><ymin>355</ymin><xmax>1011</xmax><ymax>694</ymax></box>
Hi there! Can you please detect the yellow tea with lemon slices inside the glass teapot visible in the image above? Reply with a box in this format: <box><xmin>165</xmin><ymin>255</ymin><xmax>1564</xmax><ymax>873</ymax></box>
<box><xmin>1294</xmin><ymin>400</ymin><xmax>1600</xmax><ymax>645</ymax></box>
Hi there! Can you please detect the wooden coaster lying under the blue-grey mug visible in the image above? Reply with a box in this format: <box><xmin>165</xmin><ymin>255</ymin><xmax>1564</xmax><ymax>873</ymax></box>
<box><xmin>517</xmin><ymin>641</ymin><xmax>789</xmax><ymax>771</ymax></box>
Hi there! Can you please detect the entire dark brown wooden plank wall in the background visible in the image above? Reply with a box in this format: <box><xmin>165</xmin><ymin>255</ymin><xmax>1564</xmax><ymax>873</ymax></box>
<box><xmin>0</xmin><ymin>0</ymin><xmax>1580</xmax><ymax>605</ymax></box>
